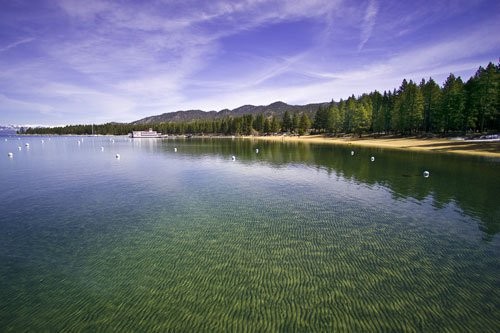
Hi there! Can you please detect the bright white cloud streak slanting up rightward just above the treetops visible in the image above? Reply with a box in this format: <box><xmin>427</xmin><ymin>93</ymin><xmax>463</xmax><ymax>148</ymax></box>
<box><xmin>181</xmin><ymin>16</ymin><xmax>500</xmax><ymax>109</ymax></box>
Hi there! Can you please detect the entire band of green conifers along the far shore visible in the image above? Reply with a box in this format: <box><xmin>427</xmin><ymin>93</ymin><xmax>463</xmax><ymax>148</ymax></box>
<box><xmin>21</xmin><ymin>63</ymin><xmax>500</xmax><ymax>136</ymax></box>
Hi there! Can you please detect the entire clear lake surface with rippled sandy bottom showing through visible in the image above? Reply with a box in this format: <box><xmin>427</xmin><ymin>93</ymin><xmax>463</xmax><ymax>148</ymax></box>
<box><xmin>0</xmin><ymin>137</ymin><xmax>500</xmax><ymax>332</ymax></box>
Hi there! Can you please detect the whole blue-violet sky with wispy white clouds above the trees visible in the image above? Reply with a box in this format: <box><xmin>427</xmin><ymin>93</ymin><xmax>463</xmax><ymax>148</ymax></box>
<box><xmin>0</xmin><ymin>0</ymin><xmax>500</xmax><ymax>125</ymax></box>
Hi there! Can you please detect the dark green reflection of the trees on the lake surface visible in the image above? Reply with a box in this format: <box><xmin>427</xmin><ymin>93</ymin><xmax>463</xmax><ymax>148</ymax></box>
<box><xmin>144</xmin><ymin>138</ymin><xmax>500</xmax><ymax>239</ymax></box>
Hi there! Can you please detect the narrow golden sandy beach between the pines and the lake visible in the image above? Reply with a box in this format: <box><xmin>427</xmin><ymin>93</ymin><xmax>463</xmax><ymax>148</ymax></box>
<box><xmin>239</xmin><ymin>135</ymin><xmax>500</xmax><ymax>158</ymax></box>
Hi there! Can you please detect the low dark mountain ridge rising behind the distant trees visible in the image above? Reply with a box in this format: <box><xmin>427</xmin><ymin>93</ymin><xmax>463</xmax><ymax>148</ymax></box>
<box><xmin>131</xmin><ymin>102</ymin><xmax>329</xmax><ymax>125</ymax></box>
